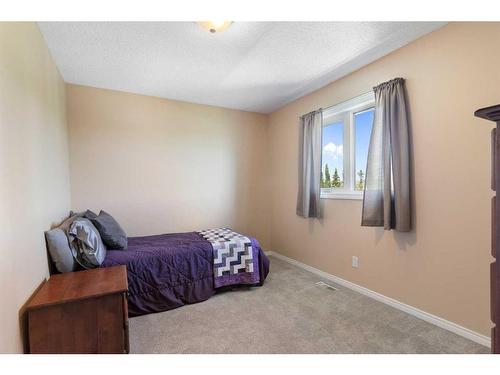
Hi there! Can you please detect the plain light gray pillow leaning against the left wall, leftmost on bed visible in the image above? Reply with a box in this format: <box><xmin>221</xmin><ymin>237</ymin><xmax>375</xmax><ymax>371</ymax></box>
<box><xmin>45</xmin><ymin>216</ymin><xmax>78</xmax><ymax>272</ymax></box>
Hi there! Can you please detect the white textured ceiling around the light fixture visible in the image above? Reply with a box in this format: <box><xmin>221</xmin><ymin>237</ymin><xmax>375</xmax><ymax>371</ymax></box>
<box><xmin>39</xmin><ymin>22</ymin><xmax>443</xmax><ymax>113</ymax></box>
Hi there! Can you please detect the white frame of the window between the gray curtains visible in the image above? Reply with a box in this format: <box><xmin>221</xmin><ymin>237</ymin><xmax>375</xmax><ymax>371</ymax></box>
<box><xmin>320</xmin><ymin>91</ymin><xmax>375</xmax><ymax>200</ymax></box>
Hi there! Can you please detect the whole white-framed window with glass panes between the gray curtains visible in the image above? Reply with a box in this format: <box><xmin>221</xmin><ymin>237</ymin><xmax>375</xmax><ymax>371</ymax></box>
<box><xmin>321</xmin><ymin>92</ymin><xmax>374</xmax><ymax>199</ymax></box>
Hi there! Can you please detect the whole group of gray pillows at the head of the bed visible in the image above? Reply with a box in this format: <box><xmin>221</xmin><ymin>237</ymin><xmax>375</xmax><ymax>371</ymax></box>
<box><xmin>45</xmin><ymin>210</ymin><xmax>127</xmax><ymax>272</ymax></box>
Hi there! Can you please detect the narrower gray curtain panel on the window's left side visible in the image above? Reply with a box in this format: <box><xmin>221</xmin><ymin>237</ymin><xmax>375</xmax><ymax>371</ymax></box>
<box><xmin>297</xmin><ymin>110</ymin><xmax>323</xmax><ymax>217</ymax></box>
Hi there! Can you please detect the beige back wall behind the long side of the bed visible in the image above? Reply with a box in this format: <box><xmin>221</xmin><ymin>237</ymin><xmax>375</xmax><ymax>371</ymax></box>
<box><xmin>67</xmin><ymin>85</ymin><xmax>269</xmax><ymax>248</ymax></box>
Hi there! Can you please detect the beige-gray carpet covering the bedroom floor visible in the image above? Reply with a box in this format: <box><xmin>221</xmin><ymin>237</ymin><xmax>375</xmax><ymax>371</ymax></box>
<box><xmin>130</xmin><ymin>257</ymin><xmax>489</xmax><ymax>353</ymax></box>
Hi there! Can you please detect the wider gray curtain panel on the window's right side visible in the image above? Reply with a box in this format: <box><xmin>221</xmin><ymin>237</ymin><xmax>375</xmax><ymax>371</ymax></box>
<box><xmin>361</xmin><ymin>78</ymin><xmax>411</xmax><ymax>232</ymax></box>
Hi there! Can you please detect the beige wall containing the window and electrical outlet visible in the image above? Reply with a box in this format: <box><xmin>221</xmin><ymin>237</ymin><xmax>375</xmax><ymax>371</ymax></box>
<box><xmin>269</xmin><ymin>23</ymin><xmax>500</xmax><ymax>335</ymax></box>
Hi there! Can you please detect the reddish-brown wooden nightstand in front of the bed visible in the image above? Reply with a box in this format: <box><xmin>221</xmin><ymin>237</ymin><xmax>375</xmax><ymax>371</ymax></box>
<box><xmin>26</xmin><ymin>266</ymin><xmax>129</xmax><ymax>353</ymax></box>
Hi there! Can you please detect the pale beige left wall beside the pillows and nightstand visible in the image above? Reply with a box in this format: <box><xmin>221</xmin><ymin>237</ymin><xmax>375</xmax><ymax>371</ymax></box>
<box><xmin>0</xmin><ymin>22</ymin><xmax>70</xmax><ymax>353</ymax></box>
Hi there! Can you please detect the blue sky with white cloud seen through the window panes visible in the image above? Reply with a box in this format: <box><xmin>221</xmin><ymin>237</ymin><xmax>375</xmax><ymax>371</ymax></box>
<box><xmin>323</xmin><ymin>110</ymin><xmax>373</xmax><ymax>185</ymax></box>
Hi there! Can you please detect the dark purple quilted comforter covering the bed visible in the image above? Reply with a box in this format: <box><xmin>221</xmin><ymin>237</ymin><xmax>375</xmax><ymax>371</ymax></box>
<box><xmin>102</xmin><ymin>232</ymin><xmax>269</xmax><ymax>316</ymax></box>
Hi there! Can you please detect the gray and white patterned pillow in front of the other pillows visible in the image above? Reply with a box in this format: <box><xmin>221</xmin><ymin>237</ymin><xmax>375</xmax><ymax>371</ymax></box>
<box><xmin>69</xmin><ymin>217</ymin><xmax>106</xmax><ymax>268</ymax></box>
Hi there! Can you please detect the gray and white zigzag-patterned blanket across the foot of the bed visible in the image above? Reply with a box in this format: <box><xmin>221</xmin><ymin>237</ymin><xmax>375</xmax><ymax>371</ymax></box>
<box><xmin>198</xmin><ymin>228</ymin><xmax>260</xmax><ymax>288</ymax></box>
